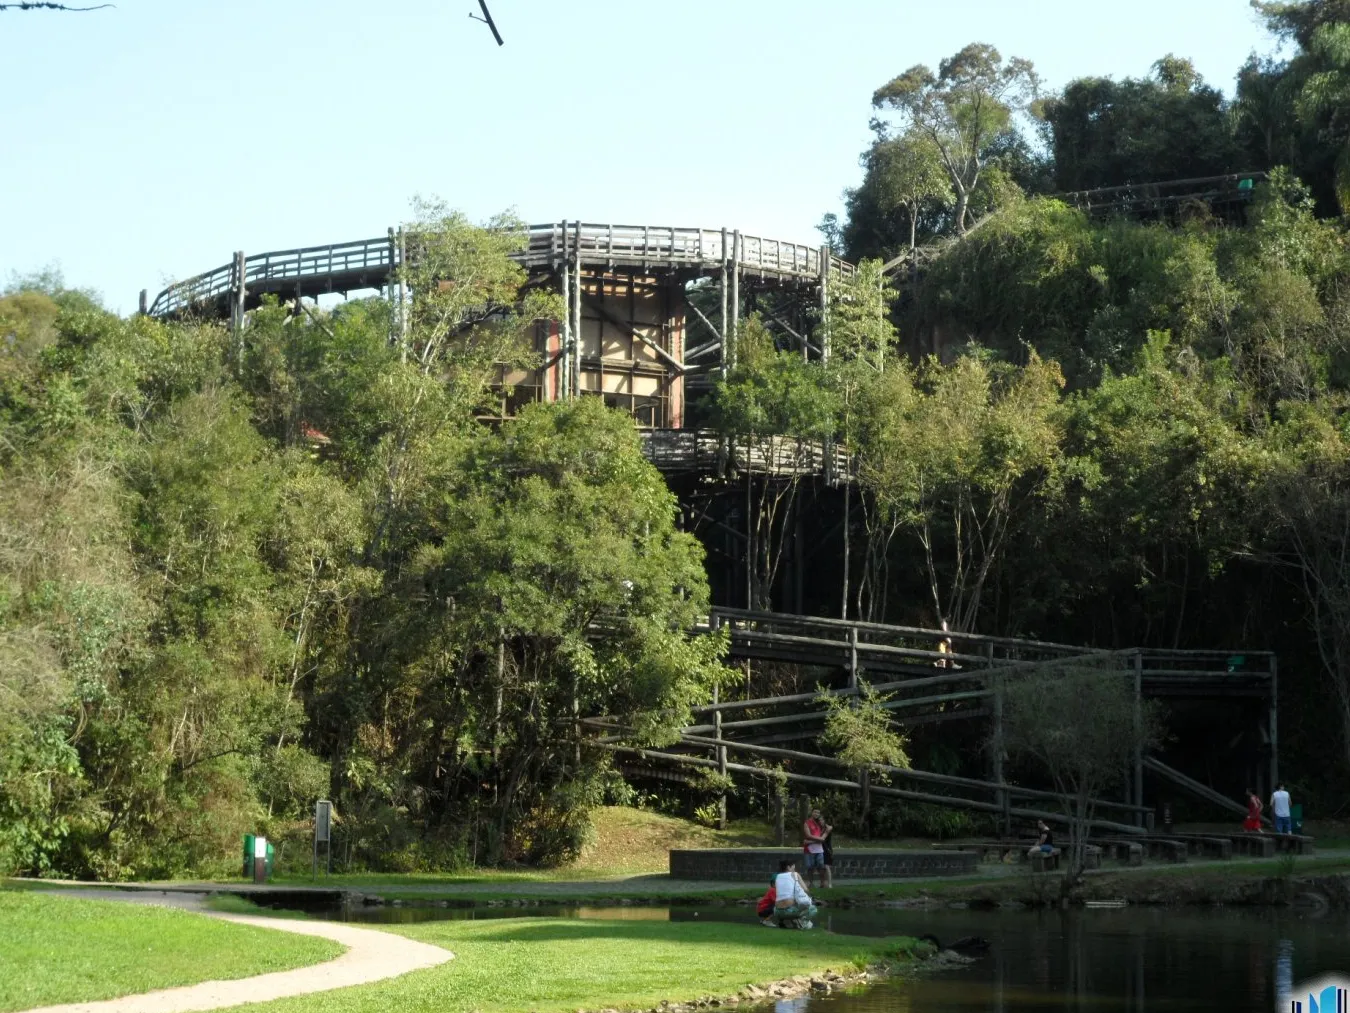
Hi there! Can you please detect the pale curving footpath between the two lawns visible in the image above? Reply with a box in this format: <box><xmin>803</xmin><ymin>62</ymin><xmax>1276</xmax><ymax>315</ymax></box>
<box><xmin>24</xmin><ymin>890</ymin><xmax>455</xmax><ymax>1013</ymax></box>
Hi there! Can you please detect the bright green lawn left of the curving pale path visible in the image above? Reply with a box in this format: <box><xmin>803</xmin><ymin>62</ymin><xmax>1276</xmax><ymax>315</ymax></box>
<box><xmin>0</xmin><ymin>890</ymin><xmax>343</xmax><ymax>1013</ymax></box>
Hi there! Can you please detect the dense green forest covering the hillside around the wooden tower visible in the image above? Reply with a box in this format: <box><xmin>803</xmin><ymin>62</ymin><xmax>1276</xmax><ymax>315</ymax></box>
<box><xmin>0</xmin><ymin>0</ymin><xmax>1350</xmax><ymax>878</ymax></box>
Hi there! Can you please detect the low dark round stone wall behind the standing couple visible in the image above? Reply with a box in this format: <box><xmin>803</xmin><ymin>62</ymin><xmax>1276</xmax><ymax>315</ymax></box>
<box><xmin>671</xmin><ymin>848</ymin><xmax>979</xmax><ymax>883</ymax></box>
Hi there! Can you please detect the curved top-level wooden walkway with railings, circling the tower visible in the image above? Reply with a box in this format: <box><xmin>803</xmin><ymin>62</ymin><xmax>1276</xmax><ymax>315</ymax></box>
<box><xmin>144</xmin><ymin>222</ymin><xmax>853</xmax><ymax>317</ymax></box>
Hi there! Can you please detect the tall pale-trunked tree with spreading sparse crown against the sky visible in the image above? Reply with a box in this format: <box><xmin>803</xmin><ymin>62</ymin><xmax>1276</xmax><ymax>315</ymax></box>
<box><xmin>872</xmin><ymin>43</ymin><xmax>1040</xmax><ymax>232</ymax></box>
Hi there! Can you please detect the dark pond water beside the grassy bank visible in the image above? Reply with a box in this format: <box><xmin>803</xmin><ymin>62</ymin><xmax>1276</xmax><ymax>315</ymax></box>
<box><xmin>257</xmin><ymin>906</ymin><xmax>1350</xmax><ymax>1013</ymax></box>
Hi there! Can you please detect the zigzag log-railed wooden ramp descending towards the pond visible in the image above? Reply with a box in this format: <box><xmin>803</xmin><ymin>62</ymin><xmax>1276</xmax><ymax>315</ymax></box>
<box><xmin>582</xmin><ymin>608</ymin><xmax>1277</xmax><ymax>832</ymax></box>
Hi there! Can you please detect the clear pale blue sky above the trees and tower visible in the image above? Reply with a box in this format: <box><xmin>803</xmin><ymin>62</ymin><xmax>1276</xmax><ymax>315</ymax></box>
<box><xmin>0</xmin><ymin>0</ymin><xmax>1273</xmax><ymax>312</ymax></box>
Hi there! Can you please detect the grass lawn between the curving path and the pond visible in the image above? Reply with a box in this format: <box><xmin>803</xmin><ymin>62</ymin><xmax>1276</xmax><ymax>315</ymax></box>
<box><xmin>250</xmin><ymin>912</ymin><xmax>913</xmax><ymax>1013</ymax></box>
